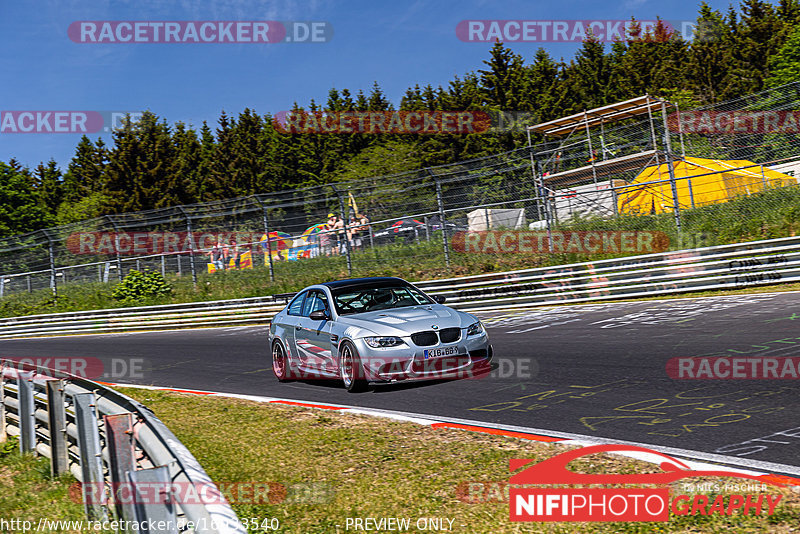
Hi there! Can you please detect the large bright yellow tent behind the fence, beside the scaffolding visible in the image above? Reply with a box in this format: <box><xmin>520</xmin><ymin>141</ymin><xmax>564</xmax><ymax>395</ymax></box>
<box><xmin>617</xmin><ymin>158</ymin><xmax>797</xmax><ymax>215</ymax></box>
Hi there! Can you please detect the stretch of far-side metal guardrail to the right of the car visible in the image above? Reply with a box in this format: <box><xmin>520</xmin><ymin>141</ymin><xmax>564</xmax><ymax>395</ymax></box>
<box><xmin>416</xmin><ymin>237</ymin><xmax>800</xmax><ymax>311</ymax></box>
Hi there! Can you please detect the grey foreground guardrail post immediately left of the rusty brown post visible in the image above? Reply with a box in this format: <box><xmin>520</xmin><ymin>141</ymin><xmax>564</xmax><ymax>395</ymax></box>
<box><xmin>72</xmin><ymin>393</ymin><xmax>107</xmax><ymax>520</ymax></box>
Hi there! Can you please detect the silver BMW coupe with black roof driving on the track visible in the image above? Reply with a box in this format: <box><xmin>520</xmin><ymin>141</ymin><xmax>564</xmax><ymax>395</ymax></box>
<box><xmin>269</xmin><ymin>277</ymin><xmax>492</xmax><ymax>392</ymax></box>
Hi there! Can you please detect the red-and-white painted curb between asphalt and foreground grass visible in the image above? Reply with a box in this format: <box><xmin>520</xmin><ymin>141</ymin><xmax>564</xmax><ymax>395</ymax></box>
<box><xmin>106</xmin><ymin>382</ymin><xmax>800</xmax><ymax>491</ymax></box>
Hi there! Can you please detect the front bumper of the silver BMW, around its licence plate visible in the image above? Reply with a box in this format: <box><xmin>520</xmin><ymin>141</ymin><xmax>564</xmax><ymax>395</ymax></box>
<box><xmin>353</xmin><ymin>332</ymin><xmax>492</xmax><ymax>383</ymax></box>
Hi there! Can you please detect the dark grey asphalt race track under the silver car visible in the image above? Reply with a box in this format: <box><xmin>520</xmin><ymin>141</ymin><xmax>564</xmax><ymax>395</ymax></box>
<box><xmin>0</xmin><ymin>293</ymin><xmax>800</xmax><ymax>474</ymax></box>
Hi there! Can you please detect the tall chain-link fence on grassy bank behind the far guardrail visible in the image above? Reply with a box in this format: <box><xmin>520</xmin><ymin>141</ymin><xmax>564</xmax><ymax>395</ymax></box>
<box><xmin>0</xmin><ymin>83</ymin><xmax>800</xmax><ymax>296</ymax></box>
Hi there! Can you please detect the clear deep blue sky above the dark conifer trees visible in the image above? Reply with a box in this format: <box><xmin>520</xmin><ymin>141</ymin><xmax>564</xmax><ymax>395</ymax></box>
<box><xmin>0</xmin><ymin>0</ymin><xmax>728</xmax><ymax>169</ymax></box>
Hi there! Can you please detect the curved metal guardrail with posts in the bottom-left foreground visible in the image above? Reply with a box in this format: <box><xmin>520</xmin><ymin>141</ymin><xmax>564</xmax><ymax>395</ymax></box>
<box><xmin>0</xmin><ymin>359</ymin><xmax>246</xmax><ymax>534</ymax></box>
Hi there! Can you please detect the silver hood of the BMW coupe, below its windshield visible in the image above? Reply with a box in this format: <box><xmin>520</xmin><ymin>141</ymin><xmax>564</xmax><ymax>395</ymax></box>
<box><xmin>337</xmin><ymin>304</ymin><xmax>468</xmax><ymax>336</ymax></box>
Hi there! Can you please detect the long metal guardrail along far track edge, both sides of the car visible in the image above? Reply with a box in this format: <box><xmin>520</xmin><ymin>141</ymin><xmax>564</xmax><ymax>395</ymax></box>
<box><xmin>0</xmin><ymin>237</ymin><xmax>800</xmax><ymax>339</ymax></box>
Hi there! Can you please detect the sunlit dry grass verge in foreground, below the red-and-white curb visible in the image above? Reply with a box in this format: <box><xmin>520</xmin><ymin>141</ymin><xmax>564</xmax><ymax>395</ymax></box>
<box><xmin>111</xmin><ymin>389</ymin><xmax>800</xmax><ymax>533</ymax></box>
